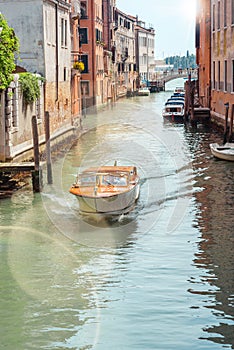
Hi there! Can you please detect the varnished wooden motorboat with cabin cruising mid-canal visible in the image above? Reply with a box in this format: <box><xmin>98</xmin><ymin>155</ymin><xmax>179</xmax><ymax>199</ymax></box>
<box><xmin>70</xmin><ymin>165</ymin><xmax>140</xmax><ymax>215</ymax></box>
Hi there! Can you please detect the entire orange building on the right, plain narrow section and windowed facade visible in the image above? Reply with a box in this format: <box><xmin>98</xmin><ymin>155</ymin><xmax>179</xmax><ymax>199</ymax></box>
<box><xmin>196</xmin><ymin>0</ymin><xmax>234</xmax><ymax>124</ymax></box>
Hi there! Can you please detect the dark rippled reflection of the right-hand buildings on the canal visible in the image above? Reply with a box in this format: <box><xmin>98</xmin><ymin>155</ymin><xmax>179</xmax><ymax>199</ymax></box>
<box><xmin>186</xmin><ymin>126</ymin><xmax>234</xmax><ymax>348</ymax></box>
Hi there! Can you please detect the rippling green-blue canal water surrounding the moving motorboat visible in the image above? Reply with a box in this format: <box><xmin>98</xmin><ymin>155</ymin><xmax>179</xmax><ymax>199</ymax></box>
<box><xmin>0</xmin><ymin>79</ymin><xmax>234</xmax><ymax>350</ymax></box>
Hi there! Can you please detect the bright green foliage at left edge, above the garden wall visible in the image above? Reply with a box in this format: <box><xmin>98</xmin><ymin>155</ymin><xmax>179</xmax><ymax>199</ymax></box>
<box><xmin>0</xmin><ymin>13</ymin><xmax>19</xmax><ymax>90</ymax></box>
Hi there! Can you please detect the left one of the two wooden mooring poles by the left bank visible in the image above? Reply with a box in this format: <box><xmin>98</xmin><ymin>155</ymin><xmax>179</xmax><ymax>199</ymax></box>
<box><xmin>32</xmin><ymin>115</ymin><xmax>42</xmax><ymax>192</ymax></box>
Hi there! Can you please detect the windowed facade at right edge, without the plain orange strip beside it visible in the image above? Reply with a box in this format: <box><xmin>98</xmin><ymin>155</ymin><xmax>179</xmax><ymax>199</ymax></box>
<box><xmin>210</xmin><ymin>0</ymin><xmax>234</xmax><ymax>118</ymax></box>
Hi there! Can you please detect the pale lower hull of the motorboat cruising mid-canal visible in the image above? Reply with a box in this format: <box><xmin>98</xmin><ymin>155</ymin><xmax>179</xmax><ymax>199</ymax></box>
<box><xmin>77</xmin><ymin>184</ymin><xmax>139</xmax><ymax>215</ymax></box>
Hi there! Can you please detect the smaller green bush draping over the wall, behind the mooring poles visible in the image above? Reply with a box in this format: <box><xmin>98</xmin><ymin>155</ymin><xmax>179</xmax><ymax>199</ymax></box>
<box><xmin>19</xmin><ymin>72</ymin><xmax>43</xmax><ymax>105</ymax></box>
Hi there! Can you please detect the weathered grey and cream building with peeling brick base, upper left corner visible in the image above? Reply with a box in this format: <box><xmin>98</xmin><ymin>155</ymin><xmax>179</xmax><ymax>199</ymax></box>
<box><xmin>0</xmin><ymin>0</ymin><xmax>71</xmax><ymax>131</ymax></box>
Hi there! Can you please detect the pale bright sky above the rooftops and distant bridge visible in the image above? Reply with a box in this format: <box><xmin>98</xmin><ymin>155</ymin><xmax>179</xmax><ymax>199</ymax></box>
<box><xmin>116</xmin><ymin>0</ymin><xmax>196</xmax><ymax>59</ymax></box>
